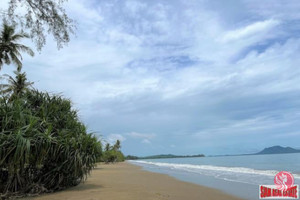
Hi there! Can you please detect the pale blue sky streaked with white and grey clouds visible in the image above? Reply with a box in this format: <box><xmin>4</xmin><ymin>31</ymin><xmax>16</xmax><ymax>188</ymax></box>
<box><xmin>0</xmin><ymin>0</ymin><xmax>300</xmax><ymax>156</ymax></box>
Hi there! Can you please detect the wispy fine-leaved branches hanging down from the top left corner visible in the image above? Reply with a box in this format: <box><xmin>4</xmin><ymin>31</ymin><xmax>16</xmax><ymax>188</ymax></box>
<box><xmin>4</xmin><ymin>0</ymin><xmax>75</xmax><ymax>50</ymax></box>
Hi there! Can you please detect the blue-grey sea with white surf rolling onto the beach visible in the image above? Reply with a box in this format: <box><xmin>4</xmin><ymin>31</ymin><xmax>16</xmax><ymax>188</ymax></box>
<box><xmin>129</xmin><ymin>153</ymin><xmax>300</xmax><ymax>199</ymax></box>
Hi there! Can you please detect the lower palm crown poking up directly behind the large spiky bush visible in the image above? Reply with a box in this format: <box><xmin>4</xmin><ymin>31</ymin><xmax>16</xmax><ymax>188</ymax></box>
<box><xmin>0</xmin><ymin>71</ymin><xmax>33</xmax><ymax>98</ymax></box>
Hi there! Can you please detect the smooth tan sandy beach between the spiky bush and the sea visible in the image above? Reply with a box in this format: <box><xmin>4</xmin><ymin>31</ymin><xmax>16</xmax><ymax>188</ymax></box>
<box><xmin>24</xmin><ymin>163</ymin><xmax>243</xmax><ymax>200</ymax></box>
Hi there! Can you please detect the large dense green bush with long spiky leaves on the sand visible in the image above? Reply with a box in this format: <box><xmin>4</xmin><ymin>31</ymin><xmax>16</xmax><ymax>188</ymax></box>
<box><xmin>0</xmin><ymin>91</ymin><xmax>102</xmax><ymax>196</ymax></box>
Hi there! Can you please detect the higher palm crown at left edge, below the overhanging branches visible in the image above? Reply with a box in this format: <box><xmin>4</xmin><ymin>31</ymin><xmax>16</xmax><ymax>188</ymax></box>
<box><xmin>0</xmin><ymin>23</ymin><xmax>34</xmax><ymax>71</ymax></box>
